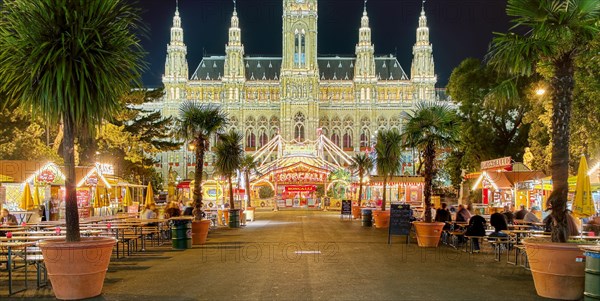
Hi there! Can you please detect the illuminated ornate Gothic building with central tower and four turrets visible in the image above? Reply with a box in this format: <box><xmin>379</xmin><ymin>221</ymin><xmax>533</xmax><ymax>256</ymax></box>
<box><xmin>148</xmin><ymin>0</ymin><xmax>436</xmax><ymax>179</ymax></box>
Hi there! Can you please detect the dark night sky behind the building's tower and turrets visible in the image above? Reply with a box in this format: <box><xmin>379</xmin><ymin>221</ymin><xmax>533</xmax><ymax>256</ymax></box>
<box><xmin>138</xmin><ymin>0</ymin><xmax>508</xmax><ymax>87</ymax></box>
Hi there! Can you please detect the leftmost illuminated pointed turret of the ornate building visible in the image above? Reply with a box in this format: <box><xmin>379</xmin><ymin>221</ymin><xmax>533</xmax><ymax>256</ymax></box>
<box><xmin>163</xmin><ymin>2</ymin><xmax>188</xmax><ymax>101</ymax></box>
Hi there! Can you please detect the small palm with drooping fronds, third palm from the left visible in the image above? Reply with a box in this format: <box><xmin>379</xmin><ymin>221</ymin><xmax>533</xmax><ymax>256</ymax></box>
<box><xmin>215</xmin><ymin>130</ymin><xmax>244</xmax><ymax>210</ymax></box>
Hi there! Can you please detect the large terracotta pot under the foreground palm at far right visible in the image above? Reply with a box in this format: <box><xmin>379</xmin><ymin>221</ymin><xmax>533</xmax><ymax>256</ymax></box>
<box><xmin>523</xmin><ymin>238</ymin><xmax>585</xmax><ymax>300</ymax></box>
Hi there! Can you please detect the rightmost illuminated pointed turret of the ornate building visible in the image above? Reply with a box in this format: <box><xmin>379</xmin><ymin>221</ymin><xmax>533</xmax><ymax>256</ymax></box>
<box><xmin>411</xmin><ymin>0</ymin><xmax>437</xmax><ymax>100</ymax></box>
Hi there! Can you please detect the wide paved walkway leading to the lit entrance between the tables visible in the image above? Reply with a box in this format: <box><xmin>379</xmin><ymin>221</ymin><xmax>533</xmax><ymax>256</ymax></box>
<box><xmin>0</xmin><ymin>211</ymin><xmax>541</xmax><ymax>300</ymax></box>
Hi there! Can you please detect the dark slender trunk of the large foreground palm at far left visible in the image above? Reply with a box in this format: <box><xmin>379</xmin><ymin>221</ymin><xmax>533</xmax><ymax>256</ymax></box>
<box><xmin>63</xmin><ymin>114</ymin><xmax>81</xmax><ymax>242</ymax></box>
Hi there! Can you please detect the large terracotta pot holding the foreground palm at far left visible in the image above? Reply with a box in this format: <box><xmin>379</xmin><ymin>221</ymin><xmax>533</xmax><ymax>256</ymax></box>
<box><xmin>39</xmin><ymin>237</ymin><xmax>116</xmax><ymax>300</ymax></box>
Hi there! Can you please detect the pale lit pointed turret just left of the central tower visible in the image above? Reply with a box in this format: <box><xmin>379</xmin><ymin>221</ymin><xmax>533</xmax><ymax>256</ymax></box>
<box><xmin>223</xmin><ymin>0</ymin><xmax>246</xmax><ymax>81</ymax></box>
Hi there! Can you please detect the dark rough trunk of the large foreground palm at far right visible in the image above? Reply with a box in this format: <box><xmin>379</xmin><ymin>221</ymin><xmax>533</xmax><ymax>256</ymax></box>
<box><xmin>549</xmin><ymin>53</ymin><xmax>574</xmax><ymax>242</ymax></box>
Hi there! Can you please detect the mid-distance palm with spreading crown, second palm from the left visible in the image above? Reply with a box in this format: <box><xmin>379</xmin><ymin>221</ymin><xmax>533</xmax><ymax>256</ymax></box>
<box><xmin>178</xmin><ymin>101</ymin><xmax>227</xmax><ymax>220</ymax></box>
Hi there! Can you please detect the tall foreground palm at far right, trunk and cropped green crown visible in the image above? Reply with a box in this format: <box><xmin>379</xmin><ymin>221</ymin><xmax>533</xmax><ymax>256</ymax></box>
<box><xmin>488</xmin><ymin>0</ymin><xmax>600</xmax><ymax>242</ymax></box>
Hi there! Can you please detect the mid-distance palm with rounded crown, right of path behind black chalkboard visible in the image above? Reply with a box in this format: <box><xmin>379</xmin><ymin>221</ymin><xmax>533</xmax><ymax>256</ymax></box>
<box><xmin>402</xmin><ymin>102</ymin><xmax>459</xmax><ymax>223</ymax></box>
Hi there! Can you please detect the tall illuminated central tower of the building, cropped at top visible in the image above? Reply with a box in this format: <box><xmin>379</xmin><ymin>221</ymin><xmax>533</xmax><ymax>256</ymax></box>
<box><xmin>280</xmin><ymin>0</ymin><xmax>319</xmax><ymax>141</ymax></box>
